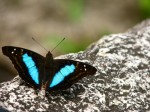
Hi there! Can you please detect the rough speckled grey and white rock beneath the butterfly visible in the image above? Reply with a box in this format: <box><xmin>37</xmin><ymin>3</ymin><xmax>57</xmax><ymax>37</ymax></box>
<box><xmin>0</xmin><ymin>20</ymin><xmax>150</xmax><ymax>112</ymax></box>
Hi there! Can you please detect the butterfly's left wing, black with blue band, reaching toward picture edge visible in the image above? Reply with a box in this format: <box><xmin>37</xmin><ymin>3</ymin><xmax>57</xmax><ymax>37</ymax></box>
<box><xmin>2</xmin><ymin>46</ymin><xmax>44</xmax><ymax>88</ymax></box>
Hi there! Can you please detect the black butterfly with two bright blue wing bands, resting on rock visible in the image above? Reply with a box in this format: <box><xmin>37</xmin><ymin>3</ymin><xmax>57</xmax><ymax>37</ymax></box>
<box><xmin>2</xmin><ymin>46</ymin><xmax>97</xmax><ymax>92</ymax></box>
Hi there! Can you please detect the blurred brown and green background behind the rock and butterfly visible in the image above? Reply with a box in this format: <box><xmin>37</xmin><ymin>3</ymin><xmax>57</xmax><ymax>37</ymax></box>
<box><xmin>0</xmin><ymin>0</ymin><xmax>150</xmax><ymax>82</ymax></box>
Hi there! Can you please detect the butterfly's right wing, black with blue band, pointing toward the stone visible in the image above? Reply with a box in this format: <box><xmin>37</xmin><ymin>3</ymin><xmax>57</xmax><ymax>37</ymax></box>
<box><xmin>49</xmin><ymin>59</ymin><xmax>96</xmax><ymax>91</ymax></box>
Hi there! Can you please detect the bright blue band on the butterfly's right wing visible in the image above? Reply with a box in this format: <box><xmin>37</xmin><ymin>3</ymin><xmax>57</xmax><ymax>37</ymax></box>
<box><xmin>50</xmin><ymin>64</ymin><xmax>75</xmax><ymax>88</ymax></box>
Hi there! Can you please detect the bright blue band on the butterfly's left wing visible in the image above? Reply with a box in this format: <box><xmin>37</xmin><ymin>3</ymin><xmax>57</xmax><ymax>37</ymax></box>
<box><xmin>22</xmin><ymin>53</ymin><xmax>39</xmax><ymax>84</ymax></box>
